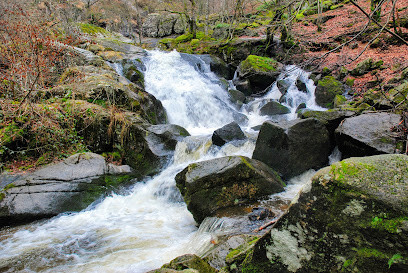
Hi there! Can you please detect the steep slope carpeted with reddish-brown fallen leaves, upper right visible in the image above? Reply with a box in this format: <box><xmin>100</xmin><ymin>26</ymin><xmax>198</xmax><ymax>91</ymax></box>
<box><xmin>293</xmin><ymin>0</ymin><xmax>408</xmax><ymax>94</ymax></box>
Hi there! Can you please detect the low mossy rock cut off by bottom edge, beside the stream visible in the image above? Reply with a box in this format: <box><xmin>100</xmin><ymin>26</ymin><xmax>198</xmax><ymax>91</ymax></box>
<box><xmin>147</xmin><ymin>254</ymin><xmax>218</xmax><ymax>273</ymax></box>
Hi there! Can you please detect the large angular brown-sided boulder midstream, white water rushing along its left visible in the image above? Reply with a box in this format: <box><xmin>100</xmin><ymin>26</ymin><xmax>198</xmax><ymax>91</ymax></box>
<box><xmin>176</xmin><ymin>156</ymin><xmax>284</xmax><ymax>223</ymax></box>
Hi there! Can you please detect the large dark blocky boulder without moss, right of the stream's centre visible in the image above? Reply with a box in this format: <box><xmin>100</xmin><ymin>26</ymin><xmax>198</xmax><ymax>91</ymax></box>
<box><xmin>252</xmin><ymin>119</ymin><xmax>330</xmax><ymax>179</ymax></box>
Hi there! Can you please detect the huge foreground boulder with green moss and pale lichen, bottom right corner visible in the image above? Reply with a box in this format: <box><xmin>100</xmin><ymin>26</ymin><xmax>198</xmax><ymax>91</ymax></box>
<box><xmin>230</xmin><ymin>155</ymin><xmax>408</xmax><ymax>273</ymax></box>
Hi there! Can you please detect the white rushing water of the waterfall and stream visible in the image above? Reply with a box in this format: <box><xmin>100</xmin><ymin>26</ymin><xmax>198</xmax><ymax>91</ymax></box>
<box><xmin>0</xmin><ymin>51</ymin><xmax>326</xmax><ymax>273</ymax></box>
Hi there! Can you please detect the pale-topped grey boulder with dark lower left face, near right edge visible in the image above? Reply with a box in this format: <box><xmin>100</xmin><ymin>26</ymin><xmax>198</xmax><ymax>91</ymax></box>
<box><xmin>335</xmin><ymin>113</ymin><xmax>400</xmax><ymax>157</ymax></box>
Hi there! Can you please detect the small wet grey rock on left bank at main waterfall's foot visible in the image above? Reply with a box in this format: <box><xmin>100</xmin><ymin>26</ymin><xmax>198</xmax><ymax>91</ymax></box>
<box><xmin>146</xmin><ymin>124</ymin><xmax>190</xmax><ymax>155</ymax></box>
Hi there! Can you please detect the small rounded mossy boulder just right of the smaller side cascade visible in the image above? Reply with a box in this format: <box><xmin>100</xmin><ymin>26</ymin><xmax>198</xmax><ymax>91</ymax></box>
<box><xmin>315</xmin><ymin>76</ymin><xmax>345</xmax><ymax>108</ymax></box>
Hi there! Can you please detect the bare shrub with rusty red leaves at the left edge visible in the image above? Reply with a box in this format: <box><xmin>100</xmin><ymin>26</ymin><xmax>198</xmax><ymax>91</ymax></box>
<box><xmin>0</xmin><ymin>6</ymin><xmax>80</xmax><ymax>100</ymax></box>
